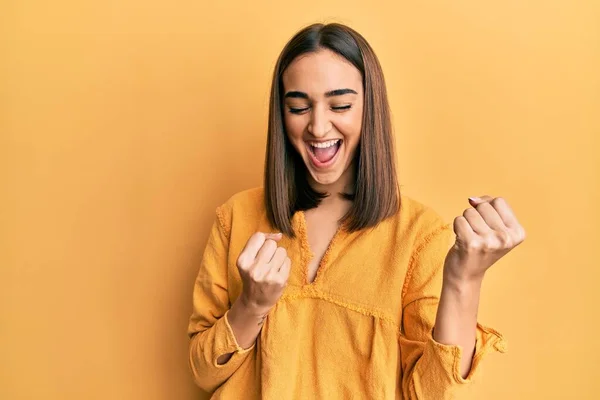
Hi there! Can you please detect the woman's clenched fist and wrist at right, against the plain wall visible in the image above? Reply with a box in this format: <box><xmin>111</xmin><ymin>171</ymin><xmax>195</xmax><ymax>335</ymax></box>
<box><xmin>444</xmin><ymin>196</ymin><xmax>525</xmax><ymax>284</ymax></box>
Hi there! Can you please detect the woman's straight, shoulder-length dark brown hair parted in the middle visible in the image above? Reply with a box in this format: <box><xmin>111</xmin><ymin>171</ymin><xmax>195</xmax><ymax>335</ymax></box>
<box><xmin>264</xmin><ymin>23</ymin><xmax>400</xmax><ymax>237</ymax></box>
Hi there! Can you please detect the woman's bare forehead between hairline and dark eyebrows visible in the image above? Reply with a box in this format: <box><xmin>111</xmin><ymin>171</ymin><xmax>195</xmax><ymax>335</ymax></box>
<box><xmin>282</xmin><ymin>50</ymin><xmax>362</xmax><ymax>95</ymax></box>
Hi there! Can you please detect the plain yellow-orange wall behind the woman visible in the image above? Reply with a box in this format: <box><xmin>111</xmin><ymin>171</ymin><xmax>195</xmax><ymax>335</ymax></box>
<box><xmin>0</xmin><ymin>0</ymin><xmax>600</xmax><ymax>400</ymax></box>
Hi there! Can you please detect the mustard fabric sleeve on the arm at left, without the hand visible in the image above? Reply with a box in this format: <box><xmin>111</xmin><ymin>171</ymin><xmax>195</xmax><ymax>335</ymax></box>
<box><xmin>188</xmin><ymin>206</ymin><xmax>254</xmax><ymax>392</ymax></box>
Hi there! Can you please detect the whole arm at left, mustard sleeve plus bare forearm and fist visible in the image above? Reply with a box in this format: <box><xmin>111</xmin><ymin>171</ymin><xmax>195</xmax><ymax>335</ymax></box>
<box><xmin>188</xmin><ymin>207</ymin><xmax>289</xmax><ymax>392</ymax></box>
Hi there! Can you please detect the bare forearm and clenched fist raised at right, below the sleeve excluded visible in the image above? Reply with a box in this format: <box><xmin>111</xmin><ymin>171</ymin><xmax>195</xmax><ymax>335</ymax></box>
<box><xmin>433</xmin><ymin>196</ymin><xmax>525</xmax><ymax>378</ymax></box>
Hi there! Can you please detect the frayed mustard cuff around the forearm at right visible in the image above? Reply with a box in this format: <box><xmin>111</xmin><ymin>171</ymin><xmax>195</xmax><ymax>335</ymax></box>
<box><xmin>428</xmin><ymin>323</ymin><xmax>508</xmax><ymax>383</ymax></box>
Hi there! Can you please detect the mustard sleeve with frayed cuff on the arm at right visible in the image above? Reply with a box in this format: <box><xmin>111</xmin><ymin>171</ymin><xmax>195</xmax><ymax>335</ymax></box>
<box><xmin>399</xmin><ymin>224</ymin><xmax>506</xmax><ymax>400</ymax></box>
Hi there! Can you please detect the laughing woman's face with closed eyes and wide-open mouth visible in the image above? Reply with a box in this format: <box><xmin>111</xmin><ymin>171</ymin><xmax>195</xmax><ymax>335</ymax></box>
<box><xmin>282</xmin><ymin>50</ymin><xmax>363</xmax><ymax>187</ymax></box>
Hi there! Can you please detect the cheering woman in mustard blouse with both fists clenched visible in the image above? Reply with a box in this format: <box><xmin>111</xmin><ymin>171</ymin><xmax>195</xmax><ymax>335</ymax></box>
<box><xmin>188</xmin><ymin>24</ymin><xmax>525</xmax><ymax>400</ymax></box>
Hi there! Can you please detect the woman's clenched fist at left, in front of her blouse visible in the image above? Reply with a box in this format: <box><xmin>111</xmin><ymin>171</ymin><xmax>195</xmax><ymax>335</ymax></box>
<box><xmin>237</xmin><ymin>232</ymin><xmax>291</xmax><ymax>315</ymax></box>
